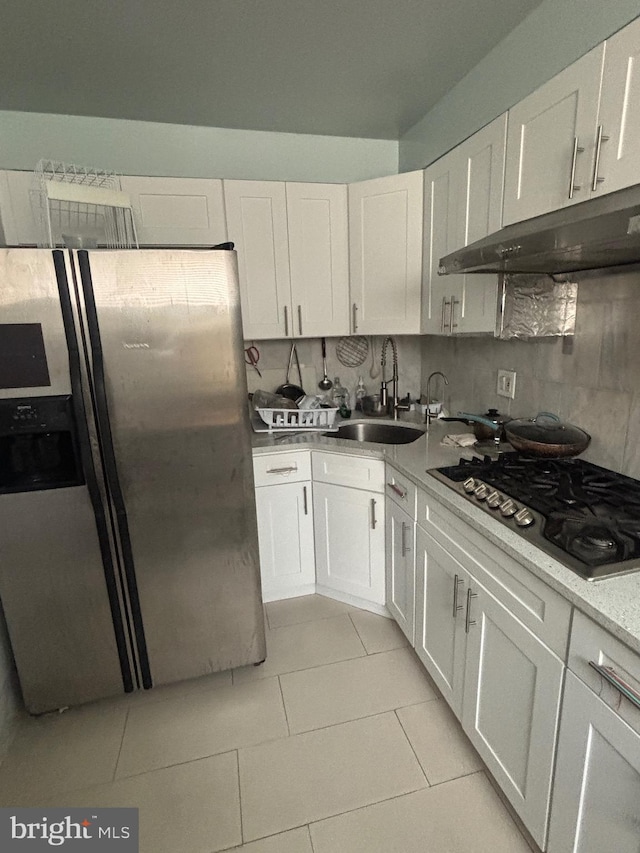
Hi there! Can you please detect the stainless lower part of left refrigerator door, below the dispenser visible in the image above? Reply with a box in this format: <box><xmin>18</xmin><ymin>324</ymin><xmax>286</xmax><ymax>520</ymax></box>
<box><xmin>0</xmin><ymin>487</ymin><xmax>123</xmax><ymax>714</ymax></box>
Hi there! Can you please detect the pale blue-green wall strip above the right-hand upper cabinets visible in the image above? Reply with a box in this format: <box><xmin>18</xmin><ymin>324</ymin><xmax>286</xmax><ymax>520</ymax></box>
<box><xmin>400</xmin><ymin>0</ymin><xmax>640</xmax><ymax>172</ymax></box>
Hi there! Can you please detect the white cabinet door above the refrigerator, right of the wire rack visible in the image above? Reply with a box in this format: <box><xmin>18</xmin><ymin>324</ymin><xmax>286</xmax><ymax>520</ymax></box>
<box><xmin>120</xmin><ymin>175</ymin><xmax>227</xmax><ymax>246</ymax></box>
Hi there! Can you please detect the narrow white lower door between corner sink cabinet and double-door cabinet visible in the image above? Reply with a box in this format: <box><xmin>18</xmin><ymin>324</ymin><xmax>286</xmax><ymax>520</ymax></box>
<box><xmin>385</xmin><ymin>499</ymin><xmax>416</xmax><ymax>645</ymax></box>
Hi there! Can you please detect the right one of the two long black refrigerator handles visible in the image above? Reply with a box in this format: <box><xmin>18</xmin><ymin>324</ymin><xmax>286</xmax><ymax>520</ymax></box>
<box><xmin>77</xmin><ymin>251</ymin><xmax>153</xmax><ymax>689</ymax></box>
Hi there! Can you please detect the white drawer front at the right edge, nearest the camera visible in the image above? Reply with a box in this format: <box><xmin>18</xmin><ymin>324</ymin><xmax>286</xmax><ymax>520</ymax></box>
<box><xmin>569</xmin><ymin>611</ymin><xmax>640</xmax><ymax>734</ymax></box>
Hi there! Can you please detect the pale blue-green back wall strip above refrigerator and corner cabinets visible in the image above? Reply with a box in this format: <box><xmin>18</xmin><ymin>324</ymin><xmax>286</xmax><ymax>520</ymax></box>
<box><xmin>0</xmin><ymin>111</ymin><xmax>398</xmax><ymax>183</ymax></box>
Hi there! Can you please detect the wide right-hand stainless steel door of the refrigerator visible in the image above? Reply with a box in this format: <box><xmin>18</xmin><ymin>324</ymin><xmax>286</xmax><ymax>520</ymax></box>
<box><xmin>78</xmin><ymin>250</ymin><xmax>265</xmax><ymax>684</ymax></box>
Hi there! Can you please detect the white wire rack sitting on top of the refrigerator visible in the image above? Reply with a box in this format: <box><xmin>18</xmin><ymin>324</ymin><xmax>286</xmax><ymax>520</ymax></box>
<box><xmin>30</xmin><ymin>160</ymin><xmax>138</xmax><ymax>249</ymax></box>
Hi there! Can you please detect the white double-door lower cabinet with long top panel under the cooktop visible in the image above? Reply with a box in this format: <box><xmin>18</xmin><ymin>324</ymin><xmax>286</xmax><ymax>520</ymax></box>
<box><xmin>415</xmin><ymin>492</ymin><xmax>570</xmax><ymax>848</ymax></box>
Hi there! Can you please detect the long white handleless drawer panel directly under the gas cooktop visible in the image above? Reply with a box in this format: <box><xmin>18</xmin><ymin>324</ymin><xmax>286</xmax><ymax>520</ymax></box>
<box><xmin>417</xmin><ymin>489</ymin><xmax>571</xmax><ymax>660</ymax></box>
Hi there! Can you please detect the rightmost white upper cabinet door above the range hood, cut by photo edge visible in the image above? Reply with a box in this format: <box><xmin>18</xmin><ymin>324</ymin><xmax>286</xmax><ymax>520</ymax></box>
<box><xmin>592</xmin><ymin>19</ymin><xmax>640</xmax><ymax>195</ymax></box>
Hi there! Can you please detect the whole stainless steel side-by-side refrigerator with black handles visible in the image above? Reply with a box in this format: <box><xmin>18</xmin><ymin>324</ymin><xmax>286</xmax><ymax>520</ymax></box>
<box><xmin>0</xmin><ymin>249</ymin><xmax>265</xmax><ymax>713</ymax></box>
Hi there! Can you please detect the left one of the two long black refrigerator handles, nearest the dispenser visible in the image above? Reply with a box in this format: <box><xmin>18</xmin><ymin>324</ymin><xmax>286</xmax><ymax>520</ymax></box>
<box><xmin>53</xmin><ymin>250</ymin><xmax>134</xmax><ymax>693</ymax></box>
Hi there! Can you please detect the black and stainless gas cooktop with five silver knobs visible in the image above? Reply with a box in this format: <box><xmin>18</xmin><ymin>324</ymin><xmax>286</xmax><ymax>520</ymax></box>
<box><xmin>428</xmin><ymin>453</ymin><xmax>640</xmax><ymax>580</ymax></box>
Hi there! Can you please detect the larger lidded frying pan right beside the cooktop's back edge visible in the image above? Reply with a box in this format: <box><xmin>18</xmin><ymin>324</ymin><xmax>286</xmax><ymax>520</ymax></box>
<box><xmin>504</xmin><ymin>412</ymin><xmax>591</xmax><ymax>459</ymax></box>
